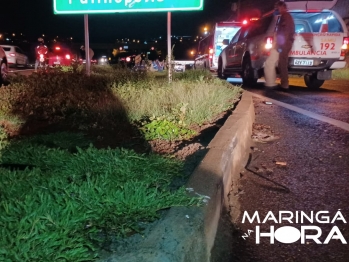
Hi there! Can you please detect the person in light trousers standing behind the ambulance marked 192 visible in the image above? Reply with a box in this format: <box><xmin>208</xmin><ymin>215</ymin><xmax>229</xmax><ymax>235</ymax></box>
<box><xmin>264</xmin><ymin>1</ymin><xmax>295</xmax><ymax>90</ymax></box>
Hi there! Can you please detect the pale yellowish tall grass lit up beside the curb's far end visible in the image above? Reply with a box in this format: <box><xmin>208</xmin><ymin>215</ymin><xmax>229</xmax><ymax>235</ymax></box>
<box><xmin>113</xmin><ymin>71</ymin><xmax>241</xmax><ymax>125</ymax></box>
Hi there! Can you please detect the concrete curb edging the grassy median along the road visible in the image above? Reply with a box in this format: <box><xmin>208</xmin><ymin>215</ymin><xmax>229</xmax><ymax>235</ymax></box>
<box><xmin>102</xmin><ymin>92</ymin><xmax>254</xmax><ymax>262</ymax></box>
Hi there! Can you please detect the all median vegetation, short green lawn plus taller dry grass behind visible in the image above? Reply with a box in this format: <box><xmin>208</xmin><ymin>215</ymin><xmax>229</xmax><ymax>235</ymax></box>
<box><xmin>0</xmin><ymin>67</ymin><xmax>241</xmax><ymax>261</ymax></box>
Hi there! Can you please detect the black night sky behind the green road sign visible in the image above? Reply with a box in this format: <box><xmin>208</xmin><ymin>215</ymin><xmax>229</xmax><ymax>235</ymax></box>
<box><xmin>0</xmin><ymin>0</ymin><xmax>237</xmax><ymax>42</ymax></box>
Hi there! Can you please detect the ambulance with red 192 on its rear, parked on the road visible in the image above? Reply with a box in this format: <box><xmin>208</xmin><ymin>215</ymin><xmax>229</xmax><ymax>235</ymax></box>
<box><xmin>218</xmin><ymin>0</ymin><xmax>349</xmax><ymax>88</ymax></box>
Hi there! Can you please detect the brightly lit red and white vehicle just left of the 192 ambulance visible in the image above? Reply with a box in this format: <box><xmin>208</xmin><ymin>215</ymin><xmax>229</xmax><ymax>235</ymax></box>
<box><xmin>194</xmin><ymin>22</ymin><xmax>242</xmax><ymax>71</ymax></box>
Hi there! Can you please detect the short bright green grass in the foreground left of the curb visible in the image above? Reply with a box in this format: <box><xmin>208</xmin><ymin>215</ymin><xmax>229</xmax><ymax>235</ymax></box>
<box><xmin>0</xmin><ymin>133</ymin><xmax>201</xmax><ymax>261</ymax></box>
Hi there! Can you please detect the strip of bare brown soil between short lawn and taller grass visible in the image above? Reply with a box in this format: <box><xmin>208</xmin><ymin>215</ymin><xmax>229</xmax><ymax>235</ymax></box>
<box><xmin>4</xmin><ymin>110</ymin><xmax>232</xmax><ymax>165</ymax></box>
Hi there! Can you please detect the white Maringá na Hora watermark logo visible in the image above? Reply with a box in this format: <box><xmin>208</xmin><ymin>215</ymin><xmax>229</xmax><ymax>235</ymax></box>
<box><xmin>242</xmin><ymin>210</ymin><xmax>347</xmax><ymax>244</ymax></box>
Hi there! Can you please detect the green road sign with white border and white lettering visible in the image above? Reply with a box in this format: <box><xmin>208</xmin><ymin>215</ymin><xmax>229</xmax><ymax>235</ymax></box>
<box><xmin>53</xmin><ymin>0</ymin><xmax>204</xmax><ymax>14</ymax></box>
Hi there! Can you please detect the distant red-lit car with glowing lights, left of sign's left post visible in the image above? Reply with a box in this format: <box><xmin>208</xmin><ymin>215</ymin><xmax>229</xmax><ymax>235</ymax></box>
<box><xmin>47</xmin><ymin>44</ymin><xmax>73</xmax><ymax>67</ymax></box>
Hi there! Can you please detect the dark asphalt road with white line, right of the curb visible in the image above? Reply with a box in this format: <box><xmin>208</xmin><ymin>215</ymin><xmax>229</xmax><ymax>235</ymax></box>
<box><xmin>218</xmin><ymin>78</ymin><xmax>349</xmax><ymax>262</ymax></box>
